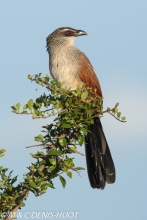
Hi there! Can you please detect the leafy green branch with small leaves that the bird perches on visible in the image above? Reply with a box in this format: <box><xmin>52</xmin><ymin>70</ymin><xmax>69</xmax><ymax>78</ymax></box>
<box><xmin>4</xmin><ymin>73</ymin><xmax>126</xmax><ymax>217</ymax></box>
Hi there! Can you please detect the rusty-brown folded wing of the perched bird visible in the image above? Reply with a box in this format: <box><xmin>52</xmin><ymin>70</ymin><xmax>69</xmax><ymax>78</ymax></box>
<box><xmin>78</xmin><ymin>52</ymin><xmax>102</xmax><ymax>97</ymax></box>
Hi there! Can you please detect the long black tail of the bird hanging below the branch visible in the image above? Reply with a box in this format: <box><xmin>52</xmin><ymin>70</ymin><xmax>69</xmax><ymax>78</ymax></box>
<box><xmin>85</xmin><ymin>118</ymin><xmax>115</xmax><ymax>189</ymax></box>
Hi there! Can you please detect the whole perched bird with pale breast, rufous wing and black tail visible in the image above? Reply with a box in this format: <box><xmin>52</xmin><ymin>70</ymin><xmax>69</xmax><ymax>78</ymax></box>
<box><xmin>46</xmin><ymin>27</ymin><xmax>116</xmax><ymax>189</ymax></box>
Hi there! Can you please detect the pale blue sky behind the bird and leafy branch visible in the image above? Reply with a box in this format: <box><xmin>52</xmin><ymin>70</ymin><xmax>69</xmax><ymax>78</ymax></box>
<box><xmin>0</xmin><ymin>0</ymin><xmax>147</xmax><ymax>220</ymax></box>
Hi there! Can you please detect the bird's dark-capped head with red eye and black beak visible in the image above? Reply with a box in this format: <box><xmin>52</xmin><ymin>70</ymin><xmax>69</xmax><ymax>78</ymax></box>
<box><xmin>46</xmin><ymin>27</ymin><xmax>87</xmax><ymax>51</ymax></box>
